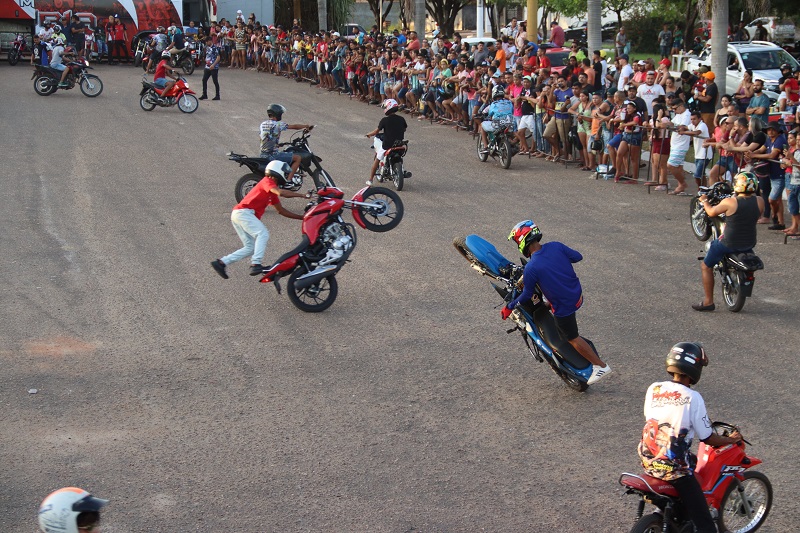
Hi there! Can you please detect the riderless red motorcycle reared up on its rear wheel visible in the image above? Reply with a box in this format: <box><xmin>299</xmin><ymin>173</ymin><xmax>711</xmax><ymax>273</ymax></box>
<box><xmin>261</xmin><ymin>187</ymin><xmax>403</xmax><ymax>313</ymax></box>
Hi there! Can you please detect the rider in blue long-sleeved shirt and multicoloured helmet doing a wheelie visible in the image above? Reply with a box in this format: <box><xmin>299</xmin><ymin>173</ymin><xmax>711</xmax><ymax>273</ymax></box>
<box><xmin>500</xmin><ymin>220</ymin><xmax>611</xmax><ymax>385</ymax></box>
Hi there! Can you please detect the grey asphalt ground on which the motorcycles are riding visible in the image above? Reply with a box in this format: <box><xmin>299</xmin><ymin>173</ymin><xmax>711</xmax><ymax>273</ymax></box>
<box><xmin>0</xmin><ymin>64</ymin><xmax>800</xmax><ymax>533</ymax></box>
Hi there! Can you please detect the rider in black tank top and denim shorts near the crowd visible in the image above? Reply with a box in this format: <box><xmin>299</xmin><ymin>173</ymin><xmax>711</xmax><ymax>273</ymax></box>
<box><xmin>692</xmin><ymin>172</ymin><xmax>764</xmax><ymax>311</ymax></box>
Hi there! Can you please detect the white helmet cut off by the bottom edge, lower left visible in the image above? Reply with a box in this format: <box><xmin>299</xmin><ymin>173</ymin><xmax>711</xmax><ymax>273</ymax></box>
<box><xmin>39</xmin><ymin>487</ymin><xmax>108</xmax><ymax>533</ymax></box>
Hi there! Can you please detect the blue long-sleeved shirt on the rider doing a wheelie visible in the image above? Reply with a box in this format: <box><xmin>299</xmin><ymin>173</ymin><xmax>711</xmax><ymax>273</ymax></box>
<box><xmin>508</xmin><ymin>241</ymin><xmax>583</xmax><ymax>317</ymax></box>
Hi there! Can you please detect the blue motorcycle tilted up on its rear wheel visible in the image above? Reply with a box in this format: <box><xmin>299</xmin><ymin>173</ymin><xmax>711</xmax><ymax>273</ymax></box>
<box><xmin>453</xmin><ymin>235</ymin><xmax>595</xmax><ymax>392</ymax></box>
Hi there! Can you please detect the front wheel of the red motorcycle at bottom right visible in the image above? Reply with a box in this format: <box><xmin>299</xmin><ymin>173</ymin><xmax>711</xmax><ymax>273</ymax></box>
<box><xmin>719</xmin><ymin>471</ymin><xmax>772</xmax><ymax>533</ymax></box>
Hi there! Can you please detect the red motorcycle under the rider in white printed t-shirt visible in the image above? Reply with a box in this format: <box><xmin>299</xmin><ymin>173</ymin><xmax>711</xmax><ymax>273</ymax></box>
<box><xmin>619</xmin><ymin>422</ymin><xmax>772</xmax><ymax>533</ymax></box>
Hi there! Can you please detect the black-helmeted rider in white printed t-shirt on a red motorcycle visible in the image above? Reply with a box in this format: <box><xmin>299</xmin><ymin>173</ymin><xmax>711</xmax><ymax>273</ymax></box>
<box><xmin>638</xmin><ymin>342</ymin><xmax>742</xmax><ymax>533</ymax></box>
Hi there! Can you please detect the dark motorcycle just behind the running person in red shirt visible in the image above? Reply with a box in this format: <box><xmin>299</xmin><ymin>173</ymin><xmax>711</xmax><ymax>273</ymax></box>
<box><xmin>228</xmin><ymin>130</ymin><xmax>336</xmax><ymax>202</ymax></box>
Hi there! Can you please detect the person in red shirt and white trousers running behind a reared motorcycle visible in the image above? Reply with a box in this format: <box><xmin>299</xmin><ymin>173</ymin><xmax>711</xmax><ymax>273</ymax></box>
<box><xmin>211</xmin><ymin>161</ymin><xmax>311</xmax><ymax>279</ymax></box>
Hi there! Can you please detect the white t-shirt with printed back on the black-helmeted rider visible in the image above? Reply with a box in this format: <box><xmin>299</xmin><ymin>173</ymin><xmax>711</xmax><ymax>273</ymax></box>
<box><xmin>638</xmin><ymin>381</ymin><xmax>711</xmax><ymax>481</ymax></box>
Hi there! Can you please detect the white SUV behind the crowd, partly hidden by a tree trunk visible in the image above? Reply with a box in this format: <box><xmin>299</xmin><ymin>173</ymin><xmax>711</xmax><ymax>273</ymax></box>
<box><xmin>686</xmin><ymin>41</ymin><xmax>800</xmax><ymax>99</ymax></box>
